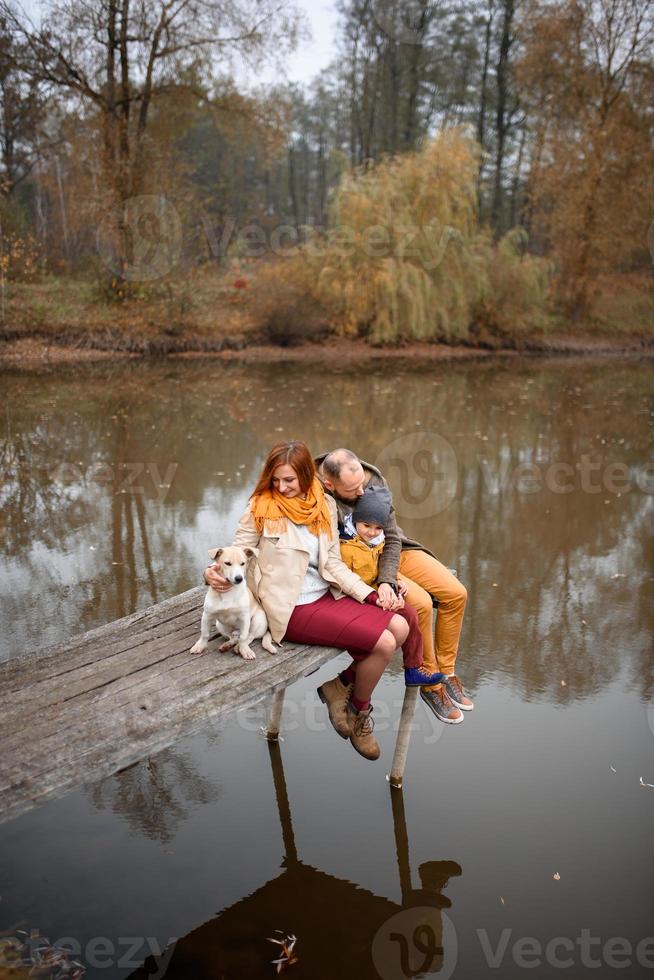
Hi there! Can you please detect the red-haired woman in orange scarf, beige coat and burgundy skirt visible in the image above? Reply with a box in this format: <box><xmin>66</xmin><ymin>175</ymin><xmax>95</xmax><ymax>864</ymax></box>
<box><xmin>205</xmin><ymin>442</ymin><xmax>409</xmax><ymax>759</ymax></box>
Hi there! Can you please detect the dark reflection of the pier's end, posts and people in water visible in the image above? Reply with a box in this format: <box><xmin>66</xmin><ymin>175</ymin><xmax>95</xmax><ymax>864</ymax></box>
<box><xmin>129</xmin><ymin>743</ymin><xmax>461</xmax><ymax>980</ymax></box>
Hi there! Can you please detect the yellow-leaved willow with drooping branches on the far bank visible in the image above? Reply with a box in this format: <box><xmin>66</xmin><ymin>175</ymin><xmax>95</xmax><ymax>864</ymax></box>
<box><xmin>305</xmin><ymin>128</ymin><xmax>549</xmax><ymax>344</ymax></box>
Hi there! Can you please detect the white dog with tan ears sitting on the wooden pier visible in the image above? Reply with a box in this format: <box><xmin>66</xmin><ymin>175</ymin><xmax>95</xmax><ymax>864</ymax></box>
<box><xmin>191</xmin><ymin>548</ymin><xmax>277</xmax><ymax>660</ymax></box>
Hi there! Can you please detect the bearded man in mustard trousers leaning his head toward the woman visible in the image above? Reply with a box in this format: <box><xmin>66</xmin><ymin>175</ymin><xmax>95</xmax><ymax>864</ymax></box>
<box><xmin>315</xmin><ymin>449</ymin><xmax>474</xmax><ymax>725</ymax></box>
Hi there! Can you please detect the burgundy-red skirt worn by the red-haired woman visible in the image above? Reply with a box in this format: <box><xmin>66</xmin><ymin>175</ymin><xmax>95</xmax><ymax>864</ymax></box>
<box><xmin>284</xmin><ymin>592</ymin><xmax>395</xmax><ymax>660</ymax></box>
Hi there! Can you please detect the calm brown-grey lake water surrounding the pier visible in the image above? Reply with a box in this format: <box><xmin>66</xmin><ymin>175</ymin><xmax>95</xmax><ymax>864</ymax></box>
<box><xmin>0</xmin><ymin>358</ymin><xmax>654</xmax><ymax>980</ymax></box>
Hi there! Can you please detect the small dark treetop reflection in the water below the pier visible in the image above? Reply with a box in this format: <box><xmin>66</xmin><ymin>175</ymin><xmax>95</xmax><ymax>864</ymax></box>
<box><xmin>89</xmin><ymin>748</ymin><xmax>221</xmax><ymax>843</ymax></box>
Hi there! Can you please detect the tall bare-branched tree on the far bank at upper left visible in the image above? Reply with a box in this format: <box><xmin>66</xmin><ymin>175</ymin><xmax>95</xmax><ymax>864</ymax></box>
<box><xmin>0</xmin><ymin>0</ymin><xmax>300</xmax><ymax>288</ymax></box>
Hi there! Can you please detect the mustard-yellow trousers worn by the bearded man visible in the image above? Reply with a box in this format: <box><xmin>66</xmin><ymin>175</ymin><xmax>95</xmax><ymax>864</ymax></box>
<box><xmin>398</xmin><ymin>550</ymin><xmax>468</xmax><ymax>674</ymax></box>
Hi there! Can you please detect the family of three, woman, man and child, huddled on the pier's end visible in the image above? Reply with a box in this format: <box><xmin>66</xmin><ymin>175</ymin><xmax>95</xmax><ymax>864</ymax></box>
<box><xmin>205</xmin><ymin>441</ymin><xmax>473</xmax><ymax>759</ymax></box>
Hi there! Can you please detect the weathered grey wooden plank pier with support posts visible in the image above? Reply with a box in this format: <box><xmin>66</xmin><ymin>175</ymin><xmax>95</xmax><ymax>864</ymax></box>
<box><xmin>0</xmin><ymin>586</ymin><xmax>417</xmax><ymax>822</ymax></box>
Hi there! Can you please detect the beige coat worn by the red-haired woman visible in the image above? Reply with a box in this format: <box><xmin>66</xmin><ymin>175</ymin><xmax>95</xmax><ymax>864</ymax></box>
<box><xmin>234</xmin><ymin>497</ymin><xmax>374</xmax><ymax>643</ymax></box>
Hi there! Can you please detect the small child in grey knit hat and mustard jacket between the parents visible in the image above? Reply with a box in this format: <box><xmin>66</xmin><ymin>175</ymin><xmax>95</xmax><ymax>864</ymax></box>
<box><xmin>338</xmin><ymin>486</ymin><xmax>443</xmax><ymax>687</ymax></box>
